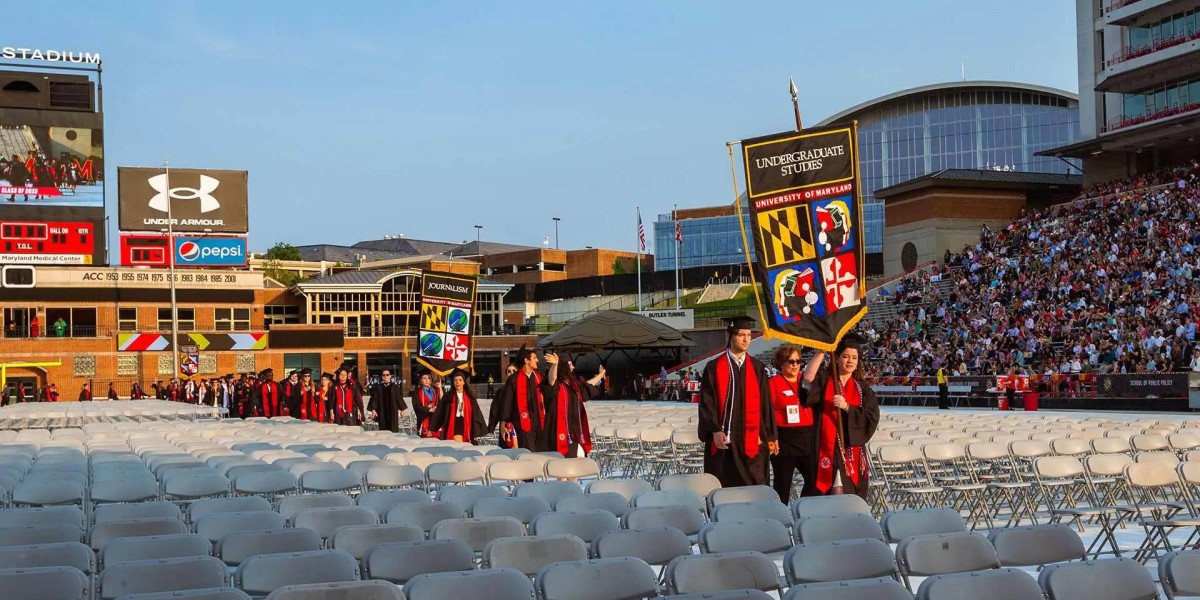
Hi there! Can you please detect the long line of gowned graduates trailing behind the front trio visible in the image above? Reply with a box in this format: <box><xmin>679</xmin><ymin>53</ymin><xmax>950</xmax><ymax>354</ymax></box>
<box><xmin>144</xmin><ymin>347</ymin><xmax>606</xmax><ymax>456</ymax></box>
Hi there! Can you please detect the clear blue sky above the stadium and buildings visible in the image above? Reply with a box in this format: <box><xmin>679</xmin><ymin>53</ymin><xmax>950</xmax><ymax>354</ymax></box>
<box><xmin>7</xmin><ymin>0</ymin><xmax>1078</xmax><ymax>251</ymax></box>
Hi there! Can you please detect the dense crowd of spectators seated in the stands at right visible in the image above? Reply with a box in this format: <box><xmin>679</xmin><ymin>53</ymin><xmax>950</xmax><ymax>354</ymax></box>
<box><xmin>860</xmin><ymin>161</ymin><xmax>1200</xmax><ymax>376</ymax></box>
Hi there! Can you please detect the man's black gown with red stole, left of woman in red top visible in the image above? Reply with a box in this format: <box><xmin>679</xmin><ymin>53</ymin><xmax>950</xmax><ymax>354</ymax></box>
<box><xmin>697</xmin><ymin>352</ymin><xmax>776</xmax><ymax>487</ymax></box>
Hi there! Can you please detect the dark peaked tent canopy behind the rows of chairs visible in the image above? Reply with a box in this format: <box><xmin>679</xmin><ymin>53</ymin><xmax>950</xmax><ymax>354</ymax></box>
<box><xmin>538</xmin><ymin>311</ymin><xmax>696</xmax><ymax>350</ymax></box>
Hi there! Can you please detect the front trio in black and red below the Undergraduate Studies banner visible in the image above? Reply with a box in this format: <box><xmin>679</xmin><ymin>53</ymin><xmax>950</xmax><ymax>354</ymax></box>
<box><xmin>697</xmin><ymin>317</ymin><xmax>880</xmax><ymax>504</ymax></box>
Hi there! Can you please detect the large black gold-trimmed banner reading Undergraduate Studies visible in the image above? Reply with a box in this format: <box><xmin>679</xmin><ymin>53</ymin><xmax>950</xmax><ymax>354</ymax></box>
<box><xmin>738</xmin><ymin>126</ymin><xmax>866</xmax><ymax>350</ymax></box>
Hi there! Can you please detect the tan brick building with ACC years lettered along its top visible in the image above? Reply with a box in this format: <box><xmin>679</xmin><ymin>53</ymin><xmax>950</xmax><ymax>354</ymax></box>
<box><xmin>0</xmin><ymin>266</ymin><xmax>534</xmax><ymax>400</ymax></box>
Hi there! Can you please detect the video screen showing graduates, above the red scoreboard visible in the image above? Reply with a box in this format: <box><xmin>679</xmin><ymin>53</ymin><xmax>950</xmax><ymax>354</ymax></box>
<box><xmin>0</xmin><ymin>124</ymin><xmax>104</xmax><ymax>211</ymax></box>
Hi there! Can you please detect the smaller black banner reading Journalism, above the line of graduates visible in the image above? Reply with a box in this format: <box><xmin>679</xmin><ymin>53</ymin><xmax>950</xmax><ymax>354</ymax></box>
<box><xmin>416</xmin><ymin>271</ymin><xmax>475</xmax><ymax>376</ymax></box>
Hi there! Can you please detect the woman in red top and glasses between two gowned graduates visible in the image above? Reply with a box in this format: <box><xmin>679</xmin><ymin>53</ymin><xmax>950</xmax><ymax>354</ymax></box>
<box><xmin>767</xmin><ymin>344</ymin><xmax>824</xmax><ymax>504</ymax></box>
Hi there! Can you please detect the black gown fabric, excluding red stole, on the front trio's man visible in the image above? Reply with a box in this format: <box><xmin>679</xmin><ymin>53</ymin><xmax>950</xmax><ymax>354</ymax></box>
<box><xmin>697</xmin><ymin>353</ymin><xmax>778</xmax><ymax>487</ymax></box>
